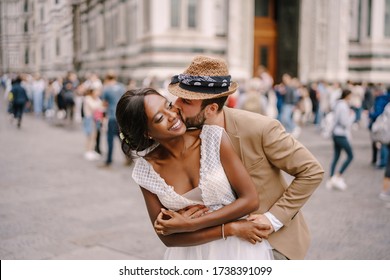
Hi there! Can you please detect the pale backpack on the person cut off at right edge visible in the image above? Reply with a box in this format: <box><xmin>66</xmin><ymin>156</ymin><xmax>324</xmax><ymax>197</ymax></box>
<box><xmin>371</xmin><ymin>103</ymin><xmax>390</xmax><ymax>145</ymax></box>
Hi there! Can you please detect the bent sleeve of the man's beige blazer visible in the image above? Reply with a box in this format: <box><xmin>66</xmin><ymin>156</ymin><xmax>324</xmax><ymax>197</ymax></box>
<box><xmin>262</xmin><ymin>120</ymin><xmax>324</xmax><ymax>226</ymax></box>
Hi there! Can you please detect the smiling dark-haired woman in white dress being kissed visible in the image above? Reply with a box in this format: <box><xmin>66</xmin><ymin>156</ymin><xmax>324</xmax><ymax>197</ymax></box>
<box><xmin>116</xmin><ymin>88</ymin><xmax>272</xmax><ymax>259</ymax></box>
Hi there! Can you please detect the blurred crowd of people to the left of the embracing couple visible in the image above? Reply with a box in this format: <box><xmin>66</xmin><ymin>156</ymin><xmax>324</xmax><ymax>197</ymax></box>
<box><xmin>1</xmin><ymin>71</ymin><xmax>132</xmax><ymax>167</ymax></box>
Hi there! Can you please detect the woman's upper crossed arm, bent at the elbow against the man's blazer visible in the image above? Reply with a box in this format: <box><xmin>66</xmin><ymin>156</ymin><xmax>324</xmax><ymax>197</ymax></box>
<box><xmin>157</xmin><ymin>133</ymin><xmax>259</xmax><ymax>235</ymax></box>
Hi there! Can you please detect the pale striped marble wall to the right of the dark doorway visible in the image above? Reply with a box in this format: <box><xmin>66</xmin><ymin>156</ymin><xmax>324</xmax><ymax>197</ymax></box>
<box><xmin>299</xmin><ymin>0</ymin><xmax>390</xmax><ymax>84</ymax></box>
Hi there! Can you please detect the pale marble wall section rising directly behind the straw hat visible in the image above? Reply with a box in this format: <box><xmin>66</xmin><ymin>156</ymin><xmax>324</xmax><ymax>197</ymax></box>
<box><xmin>76</xmin><ymin>0</ymin><xmax>233</xmax><ymax>83</ymax></box>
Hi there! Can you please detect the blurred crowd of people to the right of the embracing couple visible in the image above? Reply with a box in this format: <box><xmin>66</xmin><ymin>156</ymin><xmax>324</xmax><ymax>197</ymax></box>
<box><xmin>224</xmin><ymin>66</ymin><xmax>390</xmax><ymax>197</ymax></box>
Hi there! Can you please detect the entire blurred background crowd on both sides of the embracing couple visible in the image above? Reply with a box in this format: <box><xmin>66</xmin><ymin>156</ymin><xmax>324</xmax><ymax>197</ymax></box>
<box><xmin>1</xmin><ymin>65</ymin><xmax>390</xmax><ymax>190</ymax></box>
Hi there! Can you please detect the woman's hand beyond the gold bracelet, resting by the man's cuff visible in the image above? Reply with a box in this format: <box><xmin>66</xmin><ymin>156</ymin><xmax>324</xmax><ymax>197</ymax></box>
<box><xmin>225</xmin><ymin>220</ymin><xmax>271</xmax><ymax>244</ymax></box>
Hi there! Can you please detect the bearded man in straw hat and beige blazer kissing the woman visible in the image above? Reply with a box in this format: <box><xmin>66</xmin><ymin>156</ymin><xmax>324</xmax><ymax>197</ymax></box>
<box><xmin>161</xmin><ymin>56</ymin><xmax>324</xmax><ymax>259</ymax></box>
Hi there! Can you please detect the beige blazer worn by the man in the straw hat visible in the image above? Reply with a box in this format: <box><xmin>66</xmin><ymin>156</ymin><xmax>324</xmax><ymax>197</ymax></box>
<box><xmin>223</xmin><ymin>106</ymin><xmax>324</xmax><ymax>259</ymax></box>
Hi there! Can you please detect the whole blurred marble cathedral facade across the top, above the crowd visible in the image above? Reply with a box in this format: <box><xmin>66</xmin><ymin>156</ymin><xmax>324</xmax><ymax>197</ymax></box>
<box><xmin>0</xmin><ymin>0</ymin><xmax>390</xmax><ymax>83</ymax></box>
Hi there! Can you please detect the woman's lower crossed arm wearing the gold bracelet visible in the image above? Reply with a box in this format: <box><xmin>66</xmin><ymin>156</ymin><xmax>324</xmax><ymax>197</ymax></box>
<box><xmin>141</xmin><ymin>187</ymin><xmax>269</xmax><ymax>247</ymax></box>
